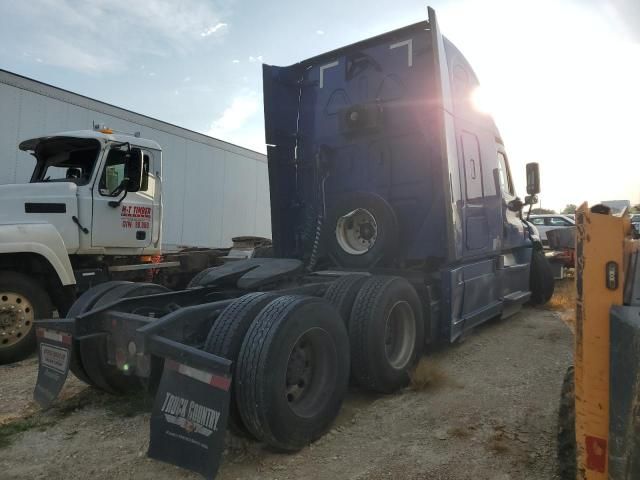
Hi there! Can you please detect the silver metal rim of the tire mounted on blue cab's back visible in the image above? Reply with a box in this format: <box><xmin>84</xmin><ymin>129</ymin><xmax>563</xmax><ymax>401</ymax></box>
<box><xmin>336</xmin><ymin>208</ymin><xmax>378</xmax><ymax>255</ymax></box>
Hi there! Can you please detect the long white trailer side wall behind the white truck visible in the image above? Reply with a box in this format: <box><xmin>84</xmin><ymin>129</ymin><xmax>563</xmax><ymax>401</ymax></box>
<box><xmin>0</xmin><ymin>70</ymin><xmax>271</xmax><ymax>249</ymax></box>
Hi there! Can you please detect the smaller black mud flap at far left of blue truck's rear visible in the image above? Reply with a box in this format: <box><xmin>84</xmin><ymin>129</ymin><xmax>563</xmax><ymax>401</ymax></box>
<box><xmin>33</xmin><ymin>327</ymin><xmax>73</xmax><ymax>409</ymax></box>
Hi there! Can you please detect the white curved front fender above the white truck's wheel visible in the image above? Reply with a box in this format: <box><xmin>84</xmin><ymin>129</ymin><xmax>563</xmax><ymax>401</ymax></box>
<box><xmin>0</xmin><ymin>223</ymin><xmax>76</xmax><ymax>285</ymax></box>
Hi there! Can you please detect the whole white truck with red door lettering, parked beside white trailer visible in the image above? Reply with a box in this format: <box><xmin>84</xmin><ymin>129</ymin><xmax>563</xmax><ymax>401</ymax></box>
<box><xmin>0</xmin><ymin>127</ymin><xmax>268</xmax><ymax>363</ymax></box>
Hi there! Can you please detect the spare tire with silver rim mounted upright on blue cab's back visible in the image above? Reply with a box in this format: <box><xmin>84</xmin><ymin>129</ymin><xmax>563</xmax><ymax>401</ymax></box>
<box><xmin>325</xmin><ymin>193</ymin><xmax>398</xmax><ymax>268</ymax></box>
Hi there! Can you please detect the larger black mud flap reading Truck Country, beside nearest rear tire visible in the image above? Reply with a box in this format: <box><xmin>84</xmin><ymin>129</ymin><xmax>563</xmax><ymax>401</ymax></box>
<box><xmin>149</xmin><ymin>360</ymin><xmax>231</xmax><ymax>478</ymax></box>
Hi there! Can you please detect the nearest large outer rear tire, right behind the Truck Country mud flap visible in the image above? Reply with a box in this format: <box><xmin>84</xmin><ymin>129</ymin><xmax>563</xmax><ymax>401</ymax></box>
<box><xmin>235</xmin><ymin>295</ymin><xmax>349</xmax><ymax>451</ymax></box>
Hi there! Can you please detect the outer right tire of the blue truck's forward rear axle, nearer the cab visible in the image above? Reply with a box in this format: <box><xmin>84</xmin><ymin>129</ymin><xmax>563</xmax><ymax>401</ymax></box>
<box><xmin>349</xmin><ymin>276</ymin><xmax>424</xmax><ymax>393</ymax></box>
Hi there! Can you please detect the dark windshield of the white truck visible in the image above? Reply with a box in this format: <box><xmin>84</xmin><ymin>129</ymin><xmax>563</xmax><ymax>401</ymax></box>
<box><xmin>31</xmin><ymin>137</ymin><xmax>100</xmax><ymax>185</ymax></box>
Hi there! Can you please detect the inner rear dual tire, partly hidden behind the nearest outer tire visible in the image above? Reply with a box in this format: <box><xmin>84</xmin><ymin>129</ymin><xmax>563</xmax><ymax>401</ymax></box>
<box><xmin>204</xmin><ymin>292</ymin><xmax>276</xmax><ymax>437</ymax></box>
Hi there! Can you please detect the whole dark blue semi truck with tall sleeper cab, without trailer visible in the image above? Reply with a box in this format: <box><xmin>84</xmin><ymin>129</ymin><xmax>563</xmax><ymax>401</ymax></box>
<box><xmin>35</xmin><ymin>9</ymin><xmax>553</xmax><ymax>477</ymax></box>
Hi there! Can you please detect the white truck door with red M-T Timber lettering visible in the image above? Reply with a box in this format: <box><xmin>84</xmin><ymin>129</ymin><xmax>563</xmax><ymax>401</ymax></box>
<box><xmin>91</xmin><ymin>146</ymin><xmax>155</xmax><ymax>248</ymax></box>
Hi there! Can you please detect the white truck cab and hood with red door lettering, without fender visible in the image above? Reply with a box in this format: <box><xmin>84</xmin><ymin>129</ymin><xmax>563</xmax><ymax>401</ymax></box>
<box><xmin>9</xmin><ymin>129</ymin><xmax>162</xmax><ymax>255</ymax></box>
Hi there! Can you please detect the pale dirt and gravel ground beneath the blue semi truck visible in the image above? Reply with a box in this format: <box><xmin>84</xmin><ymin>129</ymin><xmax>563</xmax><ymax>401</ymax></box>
<box><xmin>0</xmin><ymin>298</ymin><xmax>572</xmax><ymax>480</ymax></box>
